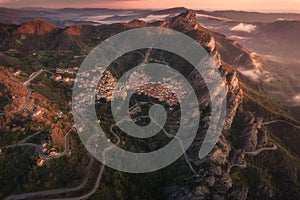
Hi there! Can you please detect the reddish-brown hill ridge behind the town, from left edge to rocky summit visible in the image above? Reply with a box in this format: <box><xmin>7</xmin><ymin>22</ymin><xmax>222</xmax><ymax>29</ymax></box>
<box><xmin>0</xmin><ymin>12</ymin><xmax>211</xmax><ymax>51</ymax></box>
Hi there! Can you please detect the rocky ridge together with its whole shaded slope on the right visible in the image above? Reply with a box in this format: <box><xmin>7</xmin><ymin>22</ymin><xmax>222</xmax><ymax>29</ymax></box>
<box><xmin>163</xmin><ymin>11</ymin><xmax>300</xmax><ymax>199</ymax></box>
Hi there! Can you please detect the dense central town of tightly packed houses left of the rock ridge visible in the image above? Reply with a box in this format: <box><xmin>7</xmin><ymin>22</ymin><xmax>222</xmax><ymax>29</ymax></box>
<box><xmin>75</xmin><ymin>67</ymin><xmax>188</xmax><ymax>106</ymax></box>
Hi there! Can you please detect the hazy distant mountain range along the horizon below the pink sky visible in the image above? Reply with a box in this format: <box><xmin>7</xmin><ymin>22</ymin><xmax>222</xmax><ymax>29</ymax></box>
<box><xmin>0</xmin><ymin>7</ymin><xmax>300</xmax><ymax>28</ymax></box>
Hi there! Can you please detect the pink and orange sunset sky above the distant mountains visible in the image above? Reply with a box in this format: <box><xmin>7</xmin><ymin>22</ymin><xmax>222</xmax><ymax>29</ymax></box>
<box><xmin>0</xmin><ymin>0</ymin><xmax>300</xmax><ymax>11</ymax></box>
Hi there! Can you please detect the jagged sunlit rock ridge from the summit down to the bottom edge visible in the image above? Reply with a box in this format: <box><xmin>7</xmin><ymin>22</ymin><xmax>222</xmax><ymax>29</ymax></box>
<box><xmin>162</xmin><ymin>11</ymin><xmax>278</xmax><ymax>200</ymax></box>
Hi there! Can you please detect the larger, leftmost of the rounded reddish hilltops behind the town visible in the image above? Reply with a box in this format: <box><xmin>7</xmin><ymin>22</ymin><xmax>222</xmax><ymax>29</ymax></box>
<box><xmin>15</xmin><ymin>20</ymin><xmax>57</xmax><ymax>35</ymax></box>
